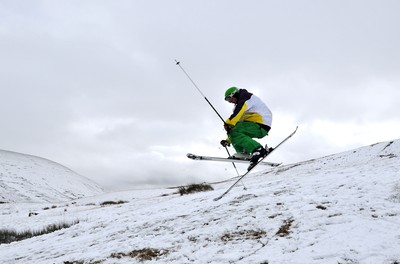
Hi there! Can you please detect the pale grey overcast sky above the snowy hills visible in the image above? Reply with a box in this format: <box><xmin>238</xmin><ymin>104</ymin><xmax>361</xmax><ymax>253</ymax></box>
<box><xmin>0</xmin><ymin>0</ymin><xmax>400</xmax><ymax>189</ymax></box>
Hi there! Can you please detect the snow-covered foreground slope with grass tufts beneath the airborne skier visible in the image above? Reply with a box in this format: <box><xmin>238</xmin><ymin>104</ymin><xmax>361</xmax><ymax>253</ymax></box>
<box><xmin>0</xmin><ymin>140</ymin><xmax>400</xmax><ymax>264</ymax></box>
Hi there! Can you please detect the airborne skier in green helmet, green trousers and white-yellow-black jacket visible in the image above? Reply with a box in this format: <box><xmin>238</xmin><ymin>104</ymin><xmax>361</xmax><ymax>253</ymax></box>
<box><xmin>221</xmin><ymin>87</ymin><xmax>272</xmax><ymax>168</ymax></box>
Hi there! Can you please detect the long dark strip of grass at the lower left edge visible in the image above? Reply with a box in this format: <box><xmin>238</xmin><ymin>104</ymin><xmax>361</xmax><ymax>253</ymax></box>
<box><xmin>0</xmin><ymin>221</ymin><xmax>79</xmax><ymax>244</ymax></box>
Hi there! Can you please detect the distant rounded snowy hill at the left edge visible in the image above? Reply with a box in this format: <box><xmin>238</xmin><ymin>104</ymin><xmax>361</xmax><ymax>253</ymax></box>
<box><xmin>0</xmin><ymin>150</ymin><xmax>102</xmax><ymax>202</ymax></box>
